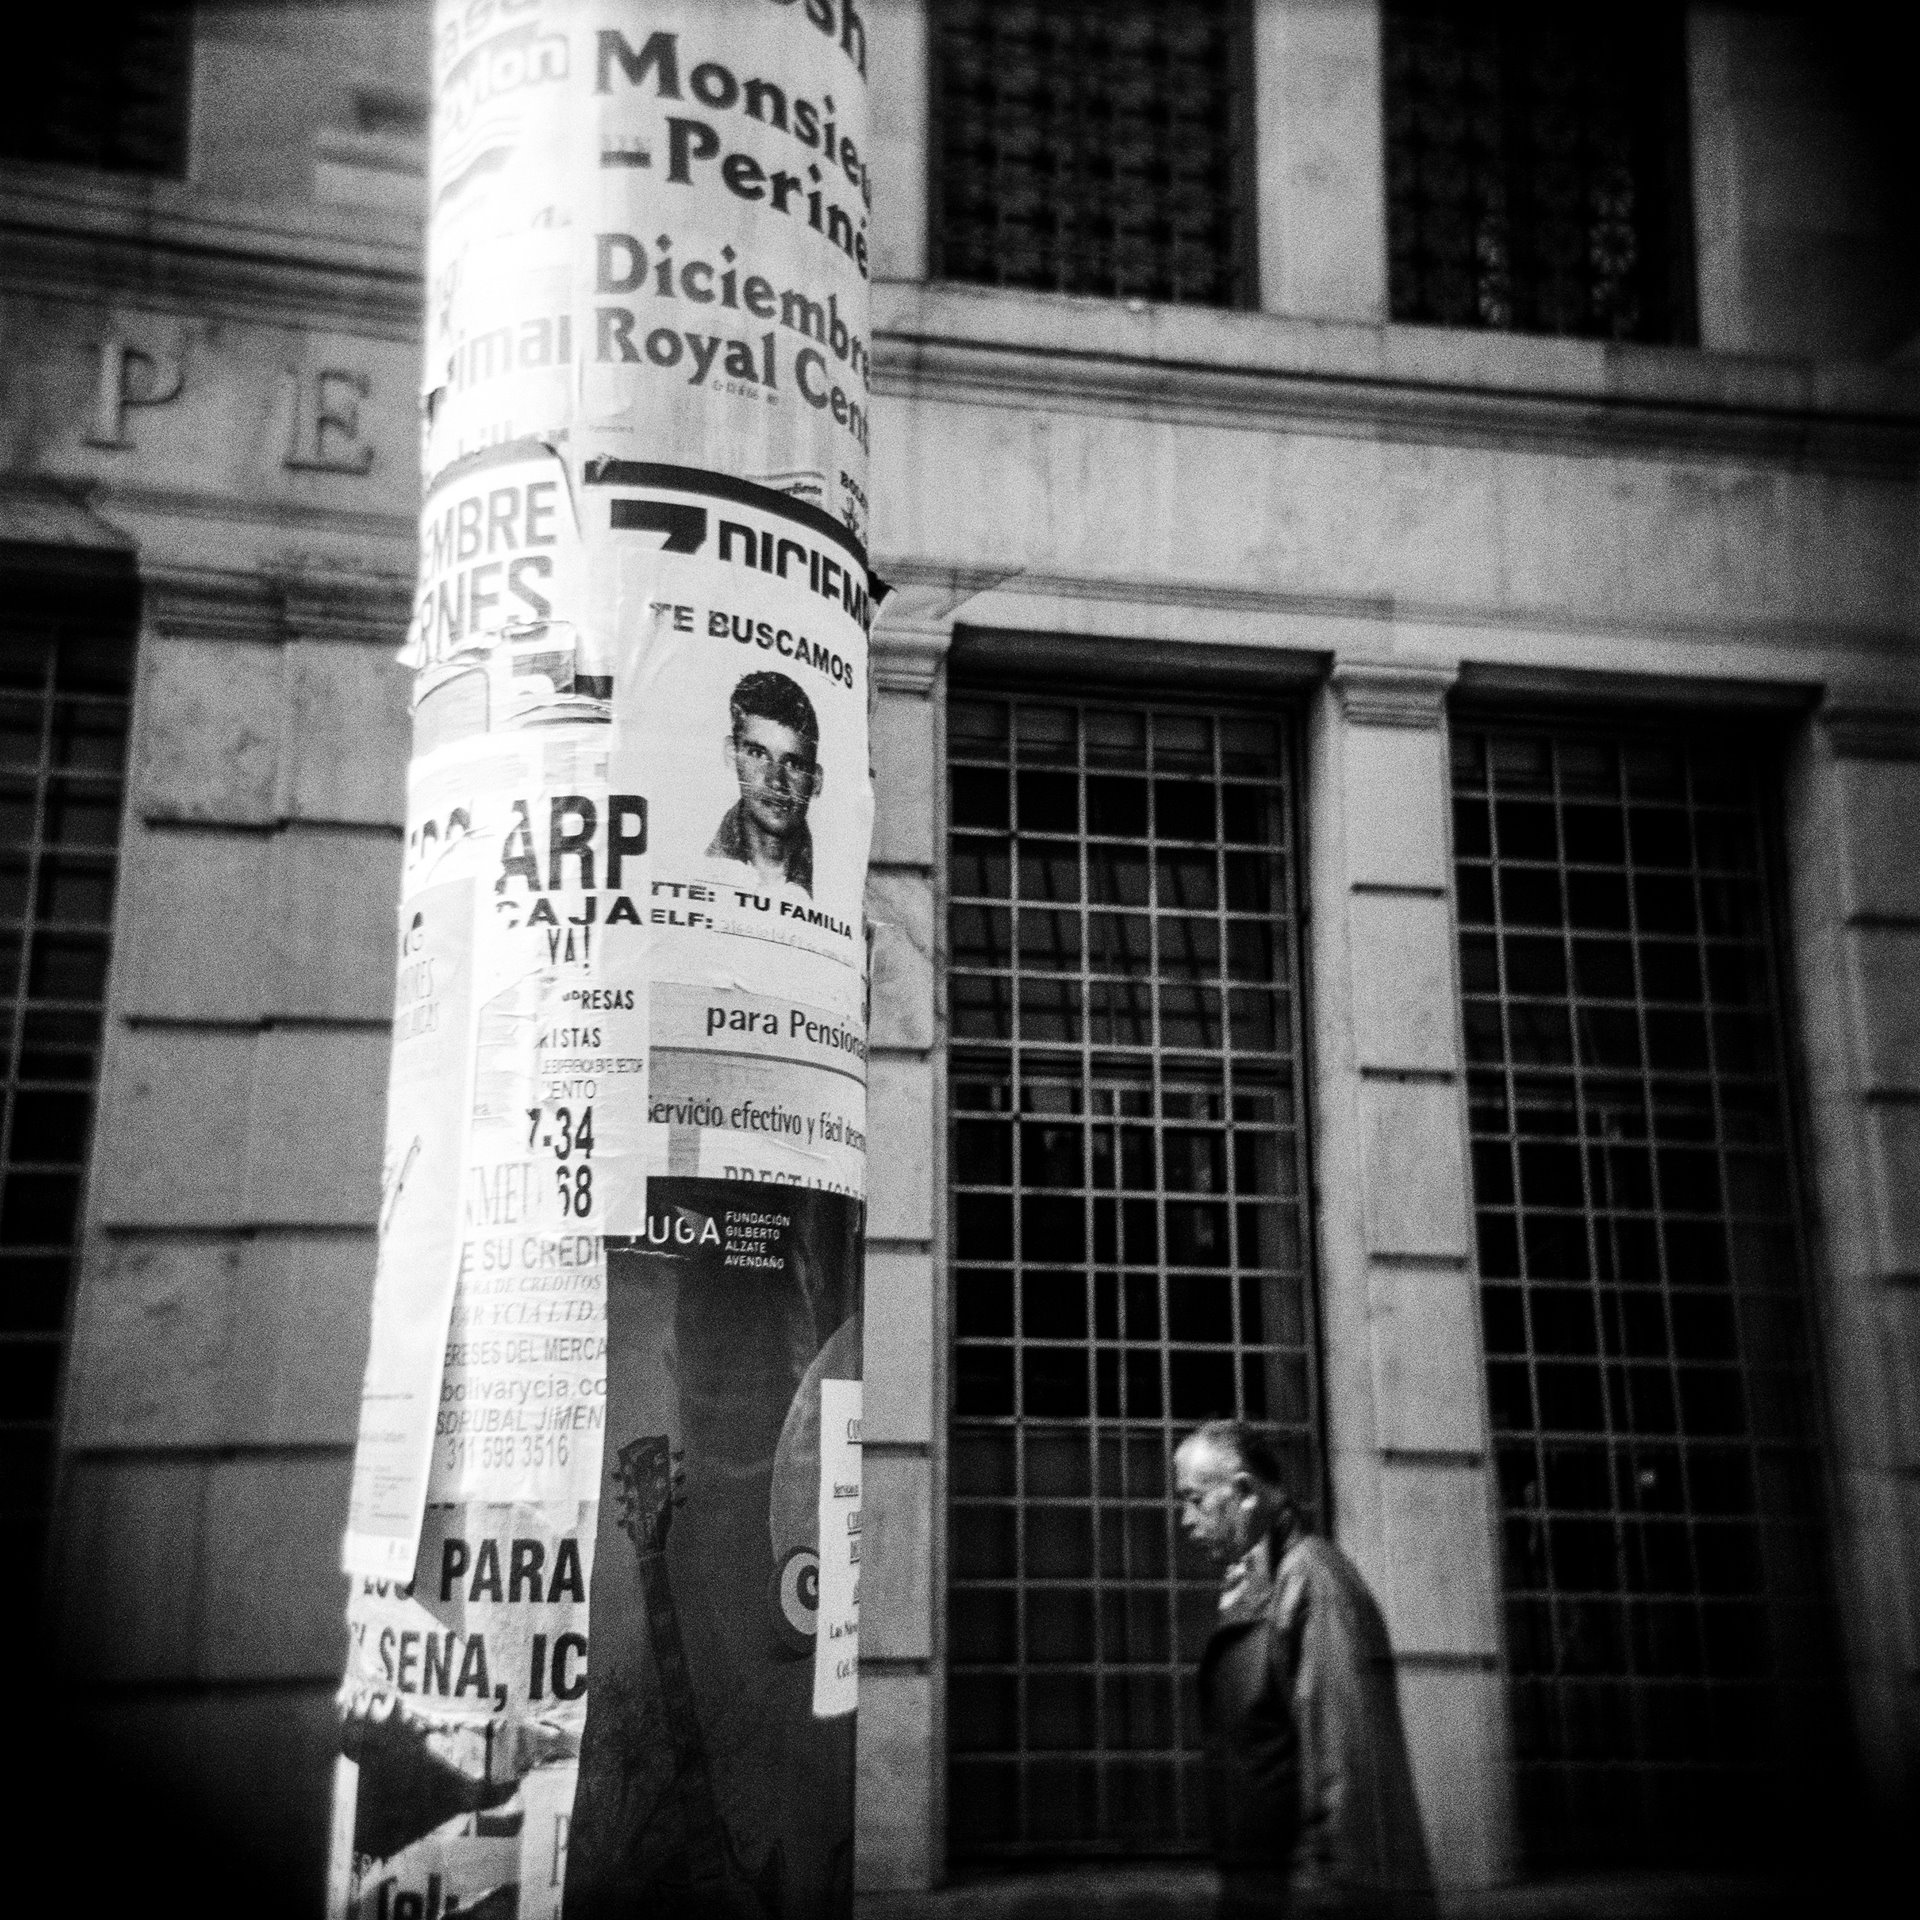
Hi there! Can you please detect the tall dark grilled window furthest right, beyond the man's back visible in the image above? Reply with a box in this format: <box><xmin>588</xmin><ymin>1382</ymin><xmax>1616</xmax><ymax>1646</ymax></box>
<box><xmin>1453</xmin><ymin>726</ymin><xmax>1832</xmax><ymax>1866</ymax></box>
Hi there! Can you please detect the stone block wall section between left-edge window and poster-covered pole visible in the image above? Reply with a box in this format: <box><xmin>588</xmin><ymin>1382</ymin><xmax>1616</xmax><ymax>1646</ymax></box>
<box><xmin>54</xmin><ymin>584</ymin><xmax>407</xmax><ymax>1889</ymax></box>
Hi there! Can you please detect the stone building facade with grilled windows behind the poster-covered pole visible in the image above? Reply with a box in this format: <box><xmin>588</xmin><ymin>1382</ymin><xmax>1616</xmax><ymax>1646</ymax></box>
<box><xmin>0</xmin><ymin>0</ymin><xmax>1920</xmax><ymax>1899</ymax></box>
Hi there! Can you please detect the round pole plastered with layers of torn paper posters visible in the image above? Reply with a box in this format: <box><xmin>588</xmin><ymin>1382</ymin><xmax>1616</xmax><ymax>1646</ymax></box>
<box><xmin>328</xmin><ymin>0</ymin><xmax>877</xmax><ymax>1920</ymax></box>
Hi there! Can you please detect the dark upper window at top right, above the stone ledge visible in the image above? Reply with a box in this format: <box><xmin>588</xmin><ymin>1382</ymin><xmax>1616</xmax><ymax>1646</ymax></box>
<box><xmin>1382</xmin><ymin>0</ymin><xmax>1693</xmax><ymax>342</ymax></box>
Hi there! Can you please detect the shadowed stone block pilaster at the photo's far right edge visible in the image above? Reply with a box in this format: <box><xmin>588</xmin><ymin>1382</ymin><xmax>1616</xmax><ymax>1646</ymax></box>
<box><xmin>1786</xmin><ymin>695</ymin><xmax>1920</xmax><ymax>1849</ymax></box>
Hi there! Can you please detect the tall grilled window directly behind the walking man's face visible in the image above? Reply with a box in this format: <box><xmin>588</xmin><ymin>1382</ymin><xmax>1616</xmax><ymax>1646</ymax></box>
<box><xmin>947</xmin><ymin>693</ymin><xmax>1319</xmax><ymax>1859</ymax></box>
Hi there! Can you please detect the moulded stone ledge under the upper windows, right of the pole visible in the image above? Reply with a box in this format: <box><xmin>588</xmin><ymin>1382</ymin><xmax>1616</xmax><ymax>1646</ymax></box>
<box><xmin>874</xmin><ymin>282</ymin><xmax>1920</xmax><ymax>480</ymax></box>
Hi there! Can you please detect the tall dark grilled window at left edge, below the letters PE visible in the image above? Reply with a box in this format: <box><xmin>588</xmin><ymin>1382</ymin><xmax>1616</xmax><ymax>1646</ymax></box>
<box><xmin>0</xmin><ymin>626</ymin><xmax>132</xmax><ymax>1617</ymax></box>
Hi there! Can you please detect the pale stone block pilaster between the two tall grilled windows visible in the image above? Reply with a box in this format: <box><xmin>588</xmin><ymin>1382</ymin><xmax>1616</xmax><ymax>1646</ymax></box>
<box><xmin>1308</xmin><ymin>659</ymin><xmax>1511</xmax><ymax>1885</ymax></box>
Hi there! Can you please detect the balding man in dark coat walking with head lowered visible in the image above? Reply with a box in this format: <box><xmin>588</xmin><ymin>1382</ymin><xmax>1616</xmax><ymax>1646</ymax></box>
<box><xmin>1173</xmin><ymin>1421</ymin><xmax>1432</xmax><ymax>1920</ymax></box>
